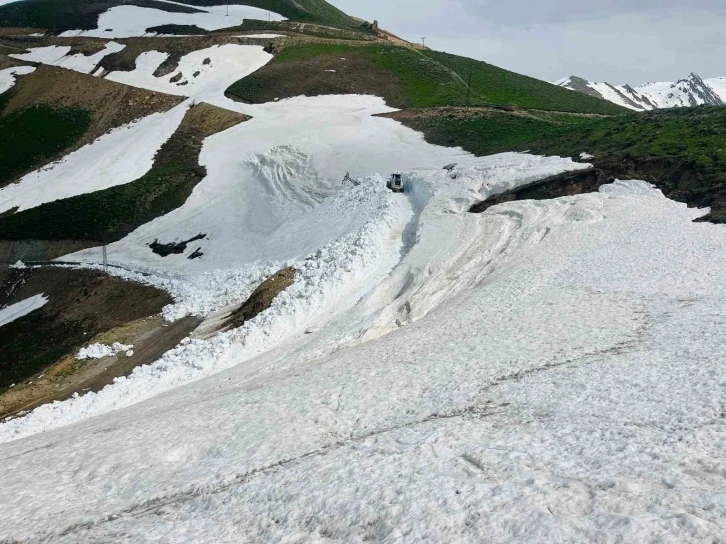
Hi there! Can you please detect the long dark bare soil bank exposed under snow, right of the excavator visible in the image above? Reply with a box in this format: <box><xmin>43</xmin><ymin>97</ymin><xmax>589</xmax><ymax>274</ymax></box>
<box><xmin>469</xmin><ymin>168</ymin><xmax>614</xmax><ymax>213</ymax></box>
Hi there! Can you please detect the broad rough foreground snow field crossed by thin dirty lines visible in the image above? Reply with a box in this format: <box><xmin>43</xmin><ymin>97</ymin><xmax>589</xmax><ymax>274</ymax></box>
<box><xmin>0</xmin><ymin>181</ymin><xmax>726</xmax><ymax>542</ymax></box>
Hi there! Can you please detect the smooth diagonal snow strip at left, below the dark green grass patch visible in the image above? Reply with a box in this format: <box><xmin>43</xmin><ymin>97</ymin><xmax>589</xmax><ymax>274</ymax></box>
<box><xmin>0</xmin><ymin>104</ymin><xmax>188</xmax><ymax>213</ymax></box>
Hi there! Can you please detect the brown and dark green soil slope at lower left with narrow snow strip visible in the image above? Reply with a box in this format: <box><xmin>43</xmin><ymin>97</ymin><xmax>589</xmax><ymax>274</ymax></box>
<box><xmin>0</xmin><ymin>268</ymin><xmax>171</xmax><ymax>391</ymax></box>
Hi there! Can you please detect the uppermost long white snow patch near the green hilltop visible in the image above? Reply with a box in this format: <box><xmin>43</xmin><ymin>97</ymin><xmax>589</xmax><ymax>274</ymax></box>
<box><xmin>61</xmin><ymin>2</ymin><xmax>285</xmax><ymax>38</ymax></box>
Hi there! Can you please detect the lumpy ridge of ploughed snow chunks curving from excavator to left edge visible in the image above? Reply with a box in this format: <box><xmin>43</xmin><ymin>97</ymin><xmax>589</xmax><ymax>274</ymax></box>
<box><xmin>0</xmin><ymin>179</ymin><xmax>411</xmax><ymax>441</ymax></box>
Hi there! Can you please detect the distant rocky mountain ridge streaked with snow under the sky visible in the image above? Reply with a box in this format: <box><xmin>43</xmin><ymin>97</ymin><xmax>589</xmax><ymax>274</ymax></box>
<box><xmin>553</xmin><ymin>73</ymin><xmax>726</xmax><ymax>111</ymax></box>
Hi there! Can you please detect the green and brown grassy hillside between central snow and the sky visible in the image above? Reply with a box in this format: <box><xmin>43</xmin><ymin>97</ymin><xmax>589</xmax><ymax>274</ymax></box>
<box><xmin>228</xmin><ymin>43</ymin><xmax>627</xmax><ymax>114</ymax></box>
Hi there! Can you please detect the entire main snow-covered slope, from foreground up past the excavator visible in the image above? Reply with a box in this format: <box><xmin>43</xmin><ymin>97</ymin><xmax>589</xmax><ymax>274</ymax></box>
<box><xmin>0</xmin><ymin>40</ymin><xmax>726</xmax><ymax>543</ymax></box>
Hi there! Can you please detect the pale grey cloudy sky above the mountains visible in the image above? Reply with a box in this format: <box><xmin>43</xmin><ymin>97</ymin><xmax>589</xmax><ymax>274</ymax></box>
<box><xmin>332</xmin><ymin>0</ymin><xmax>726</xmax><ymax>85</ymax></box>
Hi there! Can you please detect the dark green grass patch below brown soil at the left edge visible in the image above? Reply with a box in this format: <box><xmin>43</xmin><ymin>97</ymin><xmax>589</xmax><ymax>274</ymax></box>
<box><xmin>0</xmin><ymin>102</ymin><xmax>91</xmax><ymax>187</ymax></box>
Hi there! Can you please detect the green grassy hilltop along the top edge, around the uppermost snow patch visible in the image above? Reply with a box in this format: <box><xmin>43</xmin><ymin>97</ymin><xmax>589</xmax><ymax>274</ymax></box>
<box><xmin>0</xmin><ymin>0</ymin><xmax>360</xmax><ymax>30</ymax></box>
